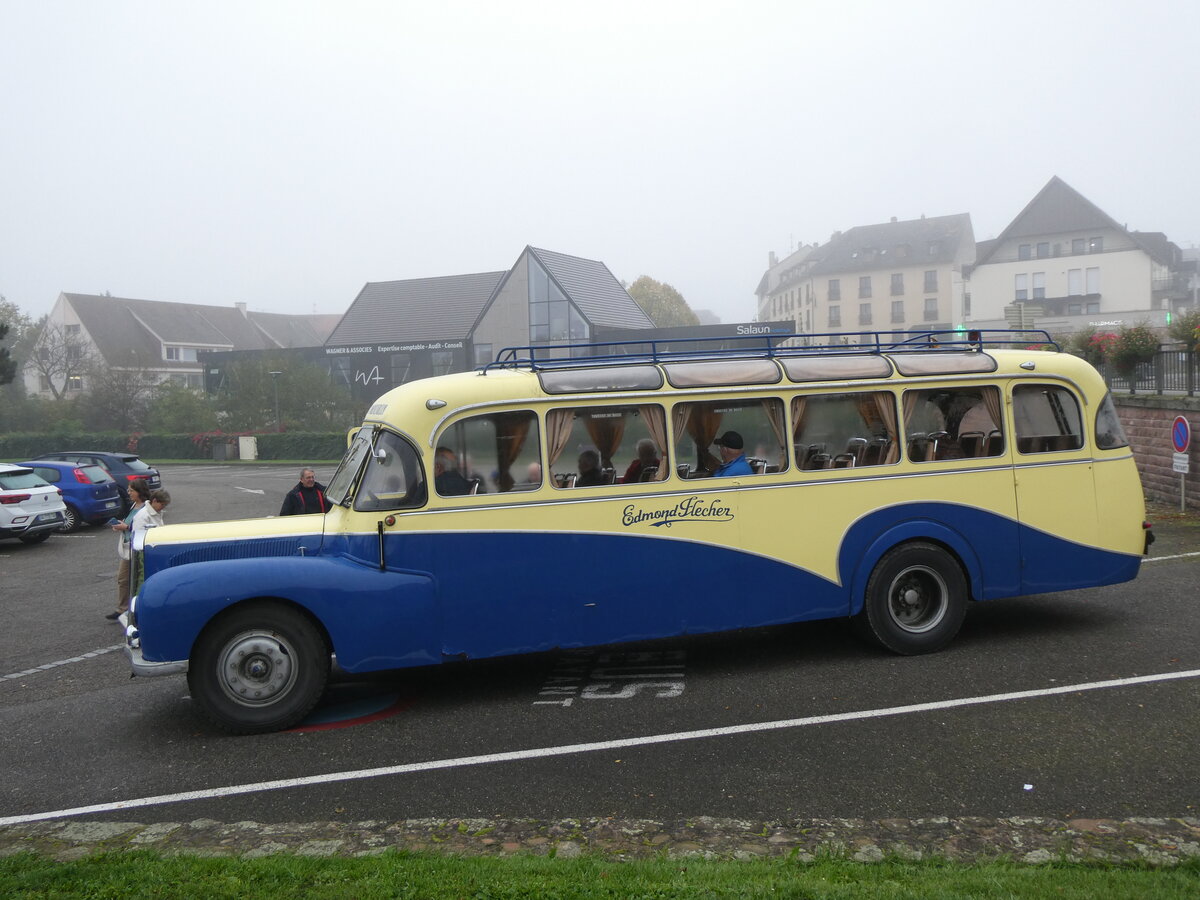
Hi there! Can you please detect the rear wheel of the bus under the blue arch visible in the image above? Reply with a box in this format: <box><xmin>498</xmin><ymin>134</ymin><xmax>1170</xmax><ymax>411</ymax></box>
<box><xmin>856</xmin><ymin>541</ymin><xmax>968</xmax><ymax>655</ymax></box>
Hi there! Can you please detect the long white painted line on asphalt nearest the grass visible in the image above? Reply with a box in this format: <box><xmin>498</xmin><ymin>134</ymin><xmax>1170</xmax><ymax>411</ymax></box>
<box><xmin>0</xmin><ymin>668</ymin><xmax>1200</xmax><ymax>826</ymax></box>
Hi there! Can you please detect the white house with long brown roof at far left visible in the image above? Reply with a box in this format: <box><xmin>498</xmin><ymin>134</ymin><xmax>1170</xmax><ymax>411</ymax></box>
<box><xmin>24</xmin><ymin>293</ymin><xmax>337</xmax><ymax>396</ymax></box>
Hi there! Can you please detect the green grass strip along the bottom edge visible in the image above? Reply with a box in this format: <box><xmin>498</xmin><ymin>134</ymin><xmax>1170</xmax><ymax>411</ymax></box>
<box><xmin>0</xmin><ymin>851</ymin><xmax>1200</xmax><ymax>900</ymax></box>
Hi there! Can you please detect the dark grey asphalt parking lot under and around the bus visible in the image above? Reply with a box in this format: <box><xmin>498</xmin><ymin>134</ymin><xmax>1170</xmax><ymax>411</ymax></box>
<box><xmin>0</xmin><ymin>466</ymin><xmax>1200</xmax><ymax>840</ymax></box>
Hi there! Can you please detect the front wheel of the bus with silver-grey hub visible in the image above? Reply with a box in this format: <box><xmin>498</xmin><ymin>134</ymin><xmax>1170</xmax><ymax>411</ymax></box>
<box><xmin>187</xmin><ymin>602</ymin><xmax>330</xmax><ymax>734</ymax></box>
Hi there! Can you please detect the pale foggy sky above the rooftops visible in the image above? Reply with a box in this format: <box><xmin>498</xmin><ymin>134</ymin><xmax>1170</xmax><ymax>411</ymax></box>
<box><xmin>0</xmin><ymin>0</ymin><xmax>1200</xmax><ymax>322</ymax></box>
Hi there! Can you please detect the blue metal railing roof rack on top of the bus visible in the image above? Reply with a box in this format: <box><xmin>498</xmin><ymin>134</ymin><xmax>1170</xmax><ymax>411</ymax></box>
<box><xmin>476</xmin><ymin>329</ymin><xmax>1062</xmax><ymax>374</ymax></box>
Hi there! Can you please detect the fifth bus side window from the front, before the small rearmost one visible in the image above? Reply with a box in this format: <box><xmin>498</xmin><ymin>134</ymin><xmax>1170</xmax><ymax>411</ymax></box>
<box><xmin>904</xmin><ymin>386</ymin><xmax>1004</xmax><ymax>462</ymax></box>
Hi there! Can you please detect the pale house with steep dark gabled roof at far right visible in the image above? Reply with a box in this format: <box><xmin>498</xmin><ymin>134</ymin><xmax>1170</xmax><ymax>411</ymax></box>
<box><xmin>966</xmin><ymin>175</ymin><xmax>1187</xmax><ymax>332</ymax></box>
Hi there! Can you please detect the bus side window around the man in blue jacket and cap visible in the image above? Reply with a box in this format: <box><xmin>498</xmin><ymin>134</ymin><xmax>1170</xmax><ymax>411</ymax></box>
<box><xmin>672</xmin><ymin>397</ymin><xmax>790</xmax><ymax>478</ymax></box>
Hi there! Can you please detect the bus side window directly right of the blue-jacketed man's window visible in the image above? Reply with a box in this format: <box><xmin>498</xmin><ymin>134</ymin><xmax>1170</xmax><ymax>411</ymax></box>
<box><xmin>792</xmin><ymin>391</ymin><xmax>900</xmax><ymax>470</ymax></box>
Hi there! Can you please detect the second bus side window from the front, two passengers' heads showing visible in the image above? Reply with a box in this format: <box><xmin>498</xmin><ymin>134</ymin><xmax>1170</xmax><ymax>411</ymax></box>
<box><xmin>546</xmin><ymin>403</ymin><xmax>671</xmax><ymax>488</ymax></box>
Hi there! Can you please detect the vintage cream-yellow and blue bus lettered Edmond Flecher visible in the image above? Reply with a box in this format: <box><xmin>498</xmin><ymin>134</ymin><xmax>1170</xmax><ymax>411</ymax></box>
<box><xmin>126</xmin><ymin>332</ymin><xmax>1148</xmax><ymax>733</ymax></box>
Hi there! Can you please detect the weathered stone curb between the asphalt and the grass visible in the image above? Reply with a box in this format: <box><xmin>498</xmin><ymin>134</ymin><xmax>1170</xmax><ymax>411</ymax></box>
<box><xmin>0</xmin><ymin>816</ymin><xmax>1200</xmax><ymax>866</ymax></box>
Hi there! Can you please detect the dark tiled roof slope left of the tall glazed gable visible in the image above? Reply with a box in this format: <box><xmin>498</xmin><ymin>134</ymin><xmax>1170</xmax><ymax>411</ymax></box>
<box><xmin>325</xmin><ymin>272</ymin><xmax>505</xmax><ymax>346</ymax></box>
